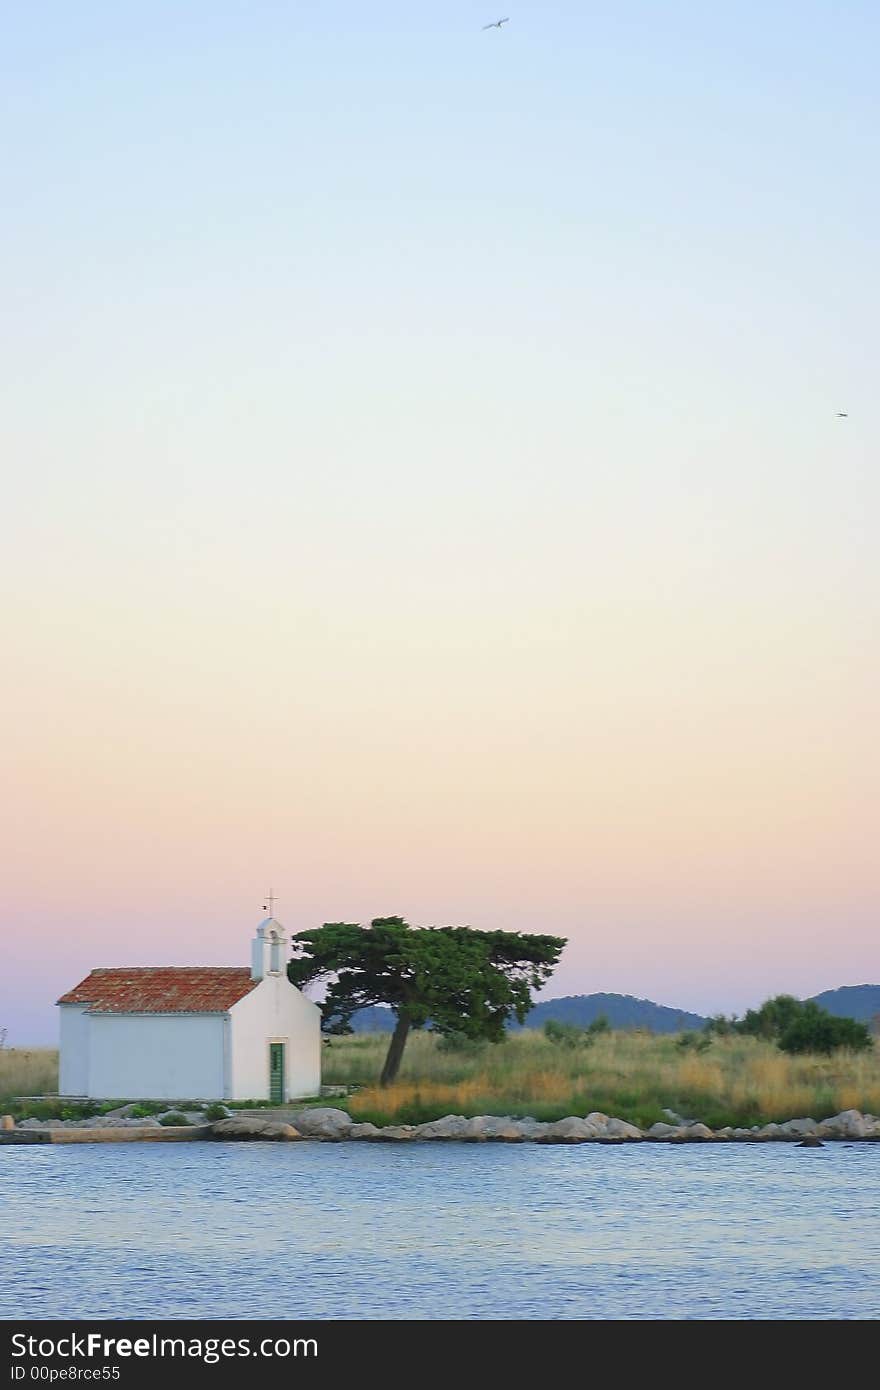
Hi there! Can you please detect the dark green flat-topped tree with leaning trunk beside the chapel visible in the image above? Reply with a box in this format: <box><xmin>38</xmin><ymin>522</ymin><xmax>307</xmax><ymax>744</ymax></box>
<box><xmin>288</xmin><ymin>917</ymin><xmax>566</xmax><ymax>1086</ymax></box>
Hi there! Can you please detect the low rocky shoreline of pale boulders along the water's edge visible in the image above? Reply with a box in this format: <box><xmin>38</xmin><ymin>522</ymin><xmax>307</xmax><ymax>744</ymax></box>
<box><xmin>0</xmin><ymin>1105</ymin><xmax>880</xmax><ymax>1148</ymax></box>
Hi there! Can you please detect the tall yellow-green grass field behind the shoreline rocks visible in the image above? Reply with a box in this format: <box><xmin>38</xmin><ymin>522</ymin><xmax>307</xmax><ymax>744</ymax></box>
<box><xmin>0</xmin><ymin>1030</ymin><xmax>880</xmax><ymax>1129</ymax></box>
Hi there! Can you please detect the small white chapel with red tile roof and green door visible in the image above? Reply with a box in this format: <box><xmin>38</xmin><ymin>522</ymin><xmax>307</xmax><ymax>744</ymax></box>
<box><xmin>58</xmin><ymin>917</ymin><xmax>321</xmax><ymax>1104</ymax></box>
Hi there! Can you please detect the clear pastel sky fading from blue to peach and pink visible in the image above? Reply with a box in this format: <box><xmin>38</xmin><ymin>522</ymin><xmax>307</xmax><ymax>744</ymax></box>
<box><xmin>0</xmin><ymin>0</ymin><xmax>880</xmax><ymax>1045</ymax></box>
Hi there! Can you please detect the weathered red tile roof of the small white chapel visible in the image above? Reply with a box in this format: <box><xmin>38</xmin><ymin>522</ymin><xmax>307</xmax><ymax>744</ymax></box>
<box><xmin>58</xmin><ymin>965</ymin><xmax>260</xmax><ymax>1013</ymax></box>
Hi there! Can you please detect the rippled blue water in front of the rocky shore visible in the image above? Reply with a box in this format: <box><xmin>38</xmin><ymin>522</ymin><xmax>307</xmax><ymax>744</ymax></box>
<box><xmin>0</xmin><ymin>1144</ymin><xmax>880</xmax><ymax>1319</ymax></box>
